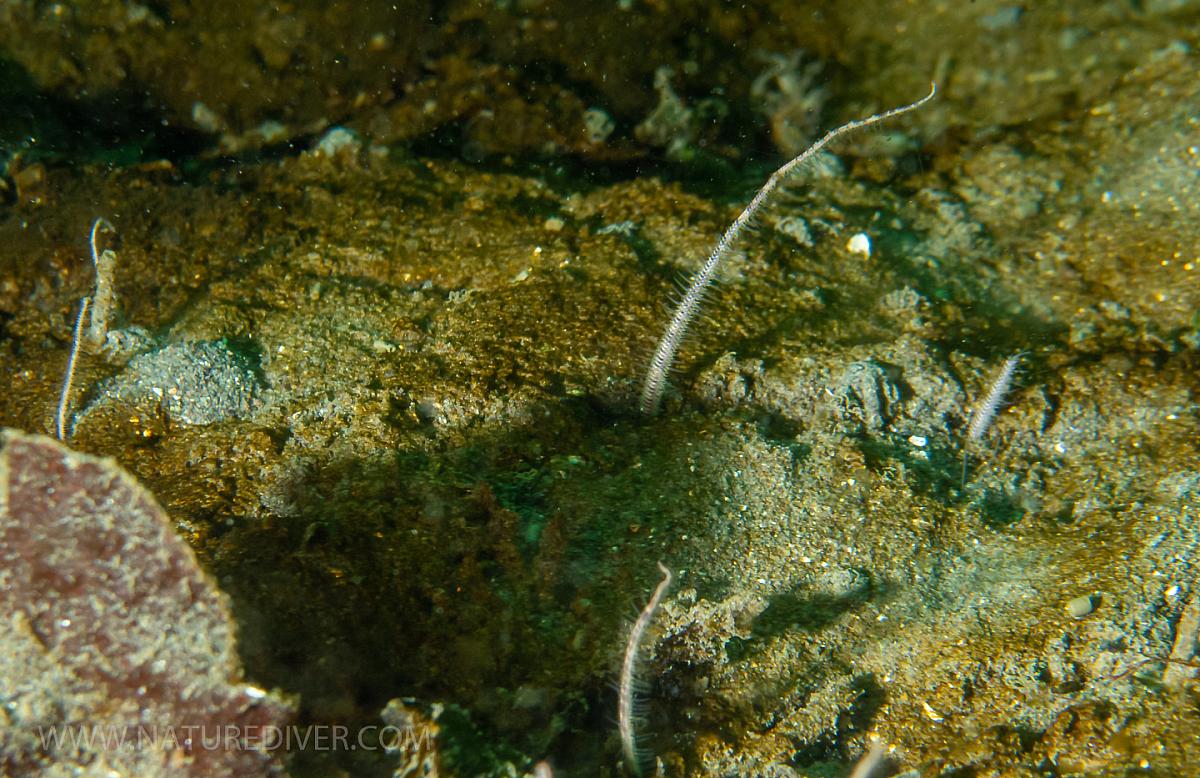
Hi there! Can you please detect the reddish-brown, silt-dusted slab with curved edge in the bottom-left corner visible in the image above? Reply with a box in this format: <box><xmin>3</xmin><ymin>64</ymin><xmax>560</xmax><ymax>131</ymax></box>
<box><xmin>0</xmin><ymin>430</ymin><xmax>290</xmax><ymax>776</ymax></box>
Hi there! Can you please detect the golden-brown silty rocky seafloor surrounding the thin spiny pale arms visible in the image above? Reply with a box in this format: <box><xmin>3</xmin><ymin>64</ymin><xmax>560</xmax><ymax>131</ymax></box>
<box><xmin>0</xmin><ymin>0</ymin><xmax>1200</xmax><ymax>778</ymax></box>
